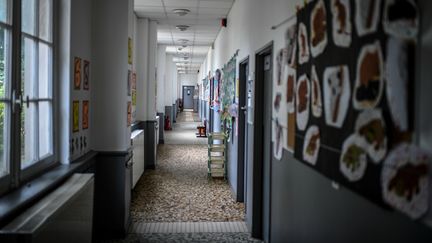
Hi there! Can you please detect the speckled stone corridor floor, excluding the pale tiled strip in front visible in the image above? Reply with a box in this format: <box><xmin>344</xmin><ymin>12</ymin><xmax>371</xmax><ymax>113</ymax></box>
<box><xmin>131</xmin><ymin>111</ymin><xmax>244</xmax><ymax>222</ymax></box>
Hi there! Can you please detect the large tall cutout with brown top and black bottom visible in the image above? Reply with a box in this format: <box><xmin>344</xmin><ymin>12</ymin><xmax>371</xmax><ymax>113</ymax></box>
<box><xmin>353</xmin><ymin>41</ymin><xmax>384</xmax><ymax>110</ymax></box>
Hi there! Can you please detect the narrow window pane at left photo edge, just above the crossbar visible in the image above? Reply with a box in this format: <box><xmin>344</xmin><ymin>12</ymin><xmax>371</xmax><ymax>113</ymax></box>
<box><xmin>0</xmin><ymin>27</ymin><xmax>10</xmax><ymax>98</ymax></box>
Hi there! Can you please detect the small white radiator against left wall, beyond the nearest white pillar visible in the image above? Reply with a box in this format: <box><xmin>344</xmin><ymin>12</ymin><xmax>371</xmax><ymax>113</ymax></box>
<box><xmin>131</xmin><ymin>130</ymin><xmax>144</xmax><ymax>188</ymax></box>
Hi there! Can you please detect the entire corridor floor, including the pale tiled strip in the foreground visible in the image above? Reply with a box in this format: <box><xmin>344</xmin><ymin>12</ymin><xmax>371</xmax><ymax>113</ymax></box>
<box><xmin>122</xmin><ymin>110</ymin><xmax>258</xmax><ymax>242</ymax></box>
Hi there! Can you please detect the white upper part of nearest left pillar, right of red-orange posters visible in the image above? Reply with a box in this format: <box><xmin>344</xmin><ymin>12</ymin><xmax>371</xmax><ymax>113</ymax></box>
<box><xmin>91</xmin><ymin>0</ymin><xmax>132</xmax><ymax>151</ymax></box>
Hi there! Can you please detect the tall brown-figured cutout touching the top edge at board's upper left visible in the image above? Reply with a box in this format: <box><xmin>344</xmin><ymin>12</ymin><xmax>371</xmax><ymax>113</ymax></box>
<box><xmin>311</xmin><ymin>0</ymin><xmax>327</xmax><ymax>57</ymax></box>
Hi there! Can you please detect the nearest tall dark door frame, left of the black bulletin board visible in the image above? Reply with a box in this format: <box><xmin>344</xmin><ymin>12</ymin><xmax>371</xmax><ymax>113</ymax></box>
<box><xmin>251</xmin><ymin>41</ymin><xmax>273</xmax><ymax>239</ymax></box>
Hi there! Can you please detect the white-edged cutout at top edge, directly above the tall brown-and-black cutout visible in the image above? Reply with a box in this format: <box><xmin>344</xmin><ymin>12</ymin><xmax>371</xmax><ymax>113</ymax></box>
<box><xmin>355</xmin><ymin>0</ymin><xmax>381</xmax><ymax>36</ymax></box>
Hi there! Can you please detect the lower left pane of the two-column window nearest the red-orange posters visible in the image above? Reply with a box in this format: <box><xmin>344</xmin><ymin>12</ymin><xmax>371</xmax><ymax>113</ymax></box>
<box><xmin>21</xmin><ymin>103</ymin><xmax>37</xmax><ymax>168</ymax></box>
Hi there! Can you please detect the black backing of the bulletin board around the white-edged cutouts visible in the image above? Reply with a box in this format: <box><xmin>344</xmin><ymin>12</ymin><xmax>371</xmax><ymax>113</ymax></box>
<box><xmin>294</xmin><ymin>0</ymin><xmax>415</xmax><ymax>209</ymax></box>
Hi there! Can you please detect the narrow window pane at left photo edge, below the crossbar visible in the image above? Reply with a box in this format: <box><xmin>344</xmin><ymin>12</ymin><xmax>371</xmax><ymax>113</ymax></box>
<box><xmin>0</xmin><ymin>103</ymin><xmax>9</xmax><ymax>177</ymax></box>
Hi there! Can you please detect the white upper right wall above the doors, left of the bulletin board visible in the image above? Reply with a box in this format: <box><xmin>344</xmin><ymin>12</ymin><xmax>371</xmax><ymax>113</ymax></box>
<box><xmin>201</xmin><ymin>0</ymin><xmax>303</xmax><ymax>82</ymax></box>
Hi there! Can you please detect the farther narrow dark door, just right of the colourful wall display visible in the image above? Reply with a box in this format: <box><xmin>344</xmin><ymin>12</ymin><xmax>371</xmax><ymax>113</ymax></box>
<box><xmin>236</xmin><ymin>56</ymin><xmax>249</xmax><ymax>202</ymax></box>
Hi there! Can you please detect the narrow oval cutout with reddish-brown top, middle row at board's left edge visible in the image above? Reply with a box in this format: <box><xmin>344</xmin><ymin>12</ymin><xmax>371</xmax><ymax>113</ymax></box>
<box><xmin>296</xmin><ymin>74</ymin><xmax>310</xmax><ymax>131</ymax></box>
